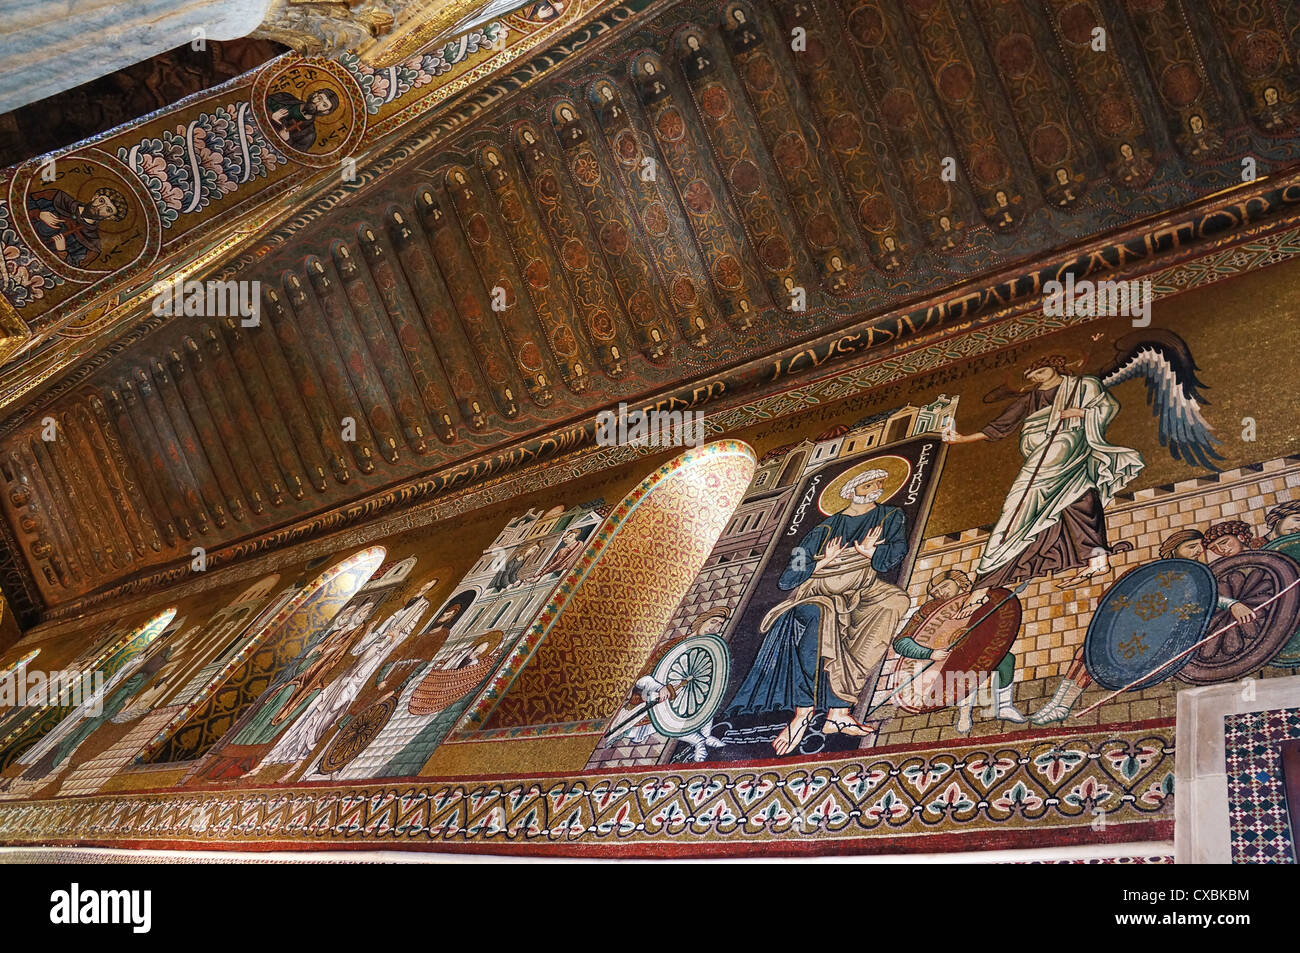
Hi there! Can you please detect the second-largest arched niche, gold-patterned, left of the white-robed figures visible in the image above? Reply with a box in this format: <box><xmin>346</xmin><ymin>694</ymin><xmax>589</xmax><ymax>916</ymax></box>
<box><xmin>137</xmin><ymin>546</ymin><xmax>385</xmax><ymax>764</ymax></box>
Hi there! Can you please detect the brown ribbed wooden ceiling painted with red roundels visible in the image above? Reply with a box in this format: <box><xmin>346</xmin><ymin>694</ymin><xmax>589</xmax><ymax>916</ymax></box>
<box><xmin>0</xmin><ymin>0</ymin><xmax>1300</xmax><ymax>621</ymax></box>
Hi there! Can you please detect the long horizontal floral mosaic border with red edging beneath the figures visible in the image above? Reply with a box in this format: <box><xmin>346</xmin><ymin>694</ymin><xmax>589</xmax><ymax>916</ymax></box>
<box><xmin>0</xmin><ymin>719</ymin><xmax>1174</xmax><ymax>857</ymax></box>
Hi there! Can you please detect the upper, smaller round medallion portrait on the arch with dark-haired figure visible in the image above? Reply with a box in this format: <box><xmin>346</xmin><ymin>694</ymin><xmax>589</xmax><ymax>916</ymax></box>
<box><xmin>252</xmin><ymin>57</ymin><xmax>365</xmax><ymax>166</ymax></box>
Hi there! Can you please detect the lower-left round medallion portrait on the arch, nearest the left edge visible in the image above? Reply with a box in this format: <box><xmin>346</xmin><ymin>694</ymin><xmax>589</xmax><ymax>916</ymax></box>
<box><xmin>9</xmin><ymin>150</ymin><xmax>163</xmax><ymax>281</ymax></box>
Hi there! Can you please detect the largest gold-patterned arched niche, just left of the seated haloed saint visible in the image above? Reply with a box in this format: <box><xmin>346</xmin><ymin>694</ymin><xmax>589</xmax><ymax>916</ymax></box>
<box><xmin>463</xmin><ymin>441</ymin><xmax>757</xmax><ymax>733</ymax></box>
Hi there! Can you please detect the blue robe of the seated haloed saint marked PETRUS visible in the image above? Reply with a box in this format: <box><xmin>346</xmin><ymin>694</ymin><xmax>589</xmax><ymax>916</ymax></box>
<box><xmin>729</xmin><ymin>506</ymin><xmax>907</xmax><ymax>714</ymax></box>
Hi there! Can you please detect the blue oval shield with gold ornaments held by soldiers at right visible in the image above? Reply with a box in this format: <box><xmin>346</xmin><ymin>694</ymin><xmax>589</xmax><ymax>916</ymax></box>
<box><xmin>1083</xmin><ymin>559</ymin><xmax>1218</xmax><ymax>692</ymax></box>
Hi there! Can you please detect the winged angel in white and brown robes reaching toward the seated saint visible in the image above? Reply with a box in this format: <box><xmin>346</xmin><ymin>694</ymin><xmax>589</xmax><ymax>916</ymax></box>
<box><xmin>944</xmin><ymin>329</ymin><xmax>1222</xmax><ymax>588</ymax></box>
